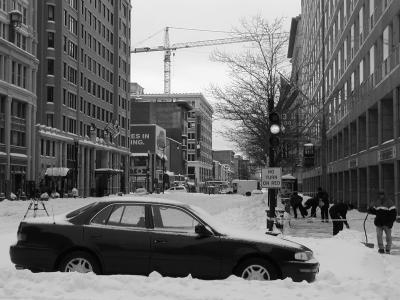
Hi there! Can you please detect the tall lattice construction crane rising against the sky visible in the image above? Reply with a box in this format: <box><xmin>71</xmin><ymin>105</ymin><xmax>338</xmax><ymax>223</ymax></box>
<box><xmin>131</xmin><ymin>27</ymin><xmax>254</xmax><ymax>94</ymax></box>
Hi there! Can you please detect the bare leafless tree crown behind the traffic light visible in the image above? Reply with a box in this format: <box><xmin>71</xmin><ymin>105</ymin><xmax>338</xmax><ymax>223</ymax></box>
<box><xmin>211</xmin><ymin>16</ymin><xmax>288</xmax><ymax>162</ymax></box>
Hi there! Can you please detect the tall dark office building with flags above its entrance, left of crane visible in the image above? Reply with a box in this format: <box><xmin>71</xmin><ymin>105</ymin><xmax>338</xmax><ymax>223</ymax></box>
<box><xmin>36</xmin><ymin>0</ymin><xmax>131</xmax><ymax>196</ymax></box>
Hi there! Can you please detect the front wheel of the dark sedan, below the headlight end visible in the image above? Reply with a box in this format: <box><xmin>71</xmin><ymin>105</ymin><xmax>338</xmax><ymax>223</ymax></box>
<box><xmin>234</xmin><ymin>258</ymin><xmax>278</xmax><ymax>281</ymax></box>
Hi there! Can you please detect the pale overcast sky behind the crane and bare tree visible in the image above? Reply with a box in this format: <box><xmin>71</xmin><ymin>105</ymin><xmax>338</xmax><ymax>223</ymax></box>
<box><xmin>131</xmin><ymin>0</ymin><xmax>301</xmax><ymax>150</ymax></box>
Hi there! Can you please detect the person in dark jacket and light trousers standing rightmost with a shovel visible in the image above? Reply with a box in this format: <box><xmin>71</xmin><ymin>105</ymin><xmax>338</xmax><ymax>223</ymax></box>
<box><xmin>368</xmin><ymin>191</ymin><xmax>397</xmax><ymax>254</ymax></box>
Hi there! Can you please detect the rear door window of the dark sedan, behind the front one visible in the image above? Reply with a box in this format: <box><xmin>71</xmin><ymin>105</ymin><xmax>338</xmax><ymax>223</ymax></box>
<box><xmin>106</xmin><ymin>205</ymin><xmax>146</xmax><ymax>228</ymax></box>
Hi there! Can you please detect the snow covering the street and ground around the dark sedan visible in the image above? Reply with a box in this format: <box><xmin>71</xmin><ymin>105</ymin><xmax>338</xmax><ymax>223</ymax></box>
<box><xmin>0</xmin><ymin>193</ymin><xmax>400</xmax><ymax>300</ymax></box>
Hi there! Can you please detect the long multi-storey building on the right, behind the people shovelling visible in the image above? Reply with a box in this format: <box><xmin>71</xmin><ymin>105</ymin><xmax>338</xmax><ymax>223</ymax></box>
<box><xmin>291</xmin><ymin>0</ymin><xmax>400</xmax><ymax>209</ymax></box>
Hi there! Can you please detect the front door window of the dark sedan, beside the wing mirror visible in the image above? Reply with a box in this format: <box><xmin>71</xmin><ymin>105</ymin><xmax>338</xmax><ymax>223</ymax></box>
<box><xmin>153</xmin><ymin>206</ymin><xmax>199</xmax><ymax>233</ymax></box>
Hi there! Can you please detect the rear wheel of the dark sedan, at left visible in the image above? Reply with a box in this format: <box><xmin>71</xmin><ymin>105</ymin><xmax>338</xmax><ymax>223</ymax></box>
<box><xmin>60</xmin><ymin>251</ymin><xmax>100</xmax><ymax>274</ymax></box>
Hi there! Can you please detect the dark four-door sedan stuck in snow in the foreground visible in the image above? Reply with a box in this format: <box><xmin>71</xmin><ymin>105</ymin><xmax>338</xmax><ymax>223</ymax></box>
<box><xmin>10</xmin><ymin>199</ymin><xmax>319</xmax><ymax>282</ymax></box>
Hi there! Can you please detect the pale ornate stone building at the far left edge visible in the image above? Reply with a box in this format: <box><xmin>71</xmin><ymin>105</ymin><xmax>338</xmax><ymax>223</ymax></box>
<box><xmin>0</xmin><ymin>0</ymin><xmax>39</xmax><ymax>197</ymax></box>
